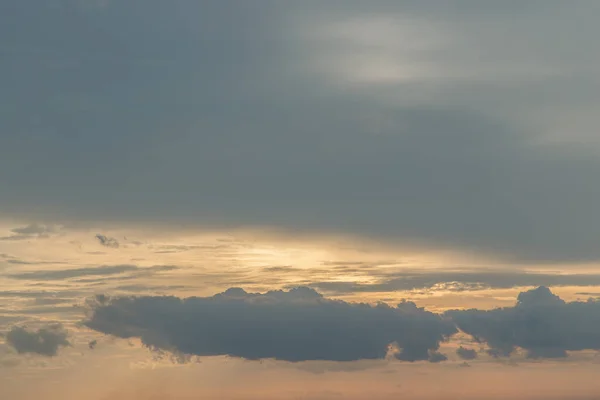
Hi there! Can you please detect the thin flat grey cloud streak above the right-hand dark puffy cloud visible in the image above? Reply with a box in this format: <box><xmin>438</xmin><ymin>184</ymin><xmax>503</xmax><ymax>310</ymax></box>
<box><xmin>311</xmin><ymin>270</ymin><xmax>600</xmax><ymax>293</ymax></box>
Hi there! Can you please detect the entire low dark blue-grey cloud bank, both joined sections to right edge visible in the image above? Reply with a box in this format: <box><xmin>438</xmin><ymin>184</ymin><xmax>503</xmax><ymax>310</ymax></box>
<box><xmin>86</xmin><ymin>287</ymin><xmax>600</xmax><ymax>362</ymax></box>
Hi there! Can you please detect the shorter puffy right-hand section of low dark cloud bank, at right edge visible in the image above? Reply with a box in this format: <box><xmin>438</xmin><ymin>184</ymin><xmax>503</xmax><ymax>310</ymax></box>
<box><xmin>446</xmin><ymin>287</ymin><xmax>600</xmax><ymax>358</ymax></box>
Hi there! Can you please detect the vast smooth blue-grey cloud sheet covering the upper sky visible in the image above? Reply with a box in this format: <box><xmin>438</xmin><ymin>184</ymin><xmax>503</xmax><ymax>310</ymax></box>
<box><xmin>0</xmin><ymin>0</ymin><xmax>600</xmax><ymax>261</ymax></box>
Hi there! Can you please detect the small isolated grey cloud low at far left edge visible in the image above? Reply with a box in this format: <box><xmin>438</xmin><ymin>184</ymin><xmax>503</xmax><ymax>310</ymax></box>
<box><xmin>6</xmin><ymin>324</ymin><xmax>71</xmax><ymax>357</ymax></box>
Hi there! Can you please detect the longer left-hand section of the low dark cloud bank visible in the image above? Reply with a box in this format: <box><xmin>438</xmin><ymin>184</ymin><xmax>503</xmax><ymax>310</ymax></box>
<box><xmin>86</xmin><ymin>288</ymin><xmax>456</xmax><ymax>361</ymax></box>
